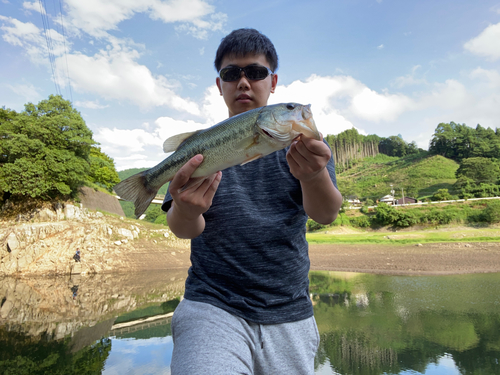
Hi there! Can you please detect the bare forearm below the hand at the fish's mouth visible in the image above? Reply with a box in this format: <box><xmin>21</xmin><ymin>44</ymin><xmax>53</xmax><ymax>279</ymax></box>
<box><xmin>300</xmin><ymin>168</ymin><xmax>342</xmax><ymax>225</ymax></box>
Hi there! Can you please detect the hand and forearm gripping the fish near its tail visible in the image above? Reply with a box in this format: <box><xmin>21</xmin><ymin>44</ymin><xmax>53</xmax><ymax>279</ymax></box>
<box><xmin>167</xmin><ymin>155</ymin><xmax>222</xmax><ymax>239</ymax></box>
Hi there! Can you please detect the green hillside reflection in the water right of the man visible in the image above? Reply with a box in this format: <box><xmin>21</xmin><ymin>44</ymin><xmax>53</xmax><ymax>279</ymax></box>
<box><xmin>310</xmin><ymin>272</ymin><xmax>500</xmax><ymax>374</ymax></box>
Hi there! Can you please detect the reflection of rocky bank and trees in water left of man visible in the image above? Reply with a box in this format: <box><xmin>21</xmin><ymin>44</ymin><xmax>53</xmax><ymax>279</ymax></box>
<box><xmin>0</xmin><ymin>271</ymin><xmax>187</xmax><ymax>374</ymax></box>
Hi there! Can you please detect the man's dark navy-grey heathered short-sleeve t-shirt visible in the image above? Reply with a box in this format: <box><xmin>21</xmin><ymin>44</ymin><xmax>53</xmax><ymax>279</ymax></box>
<box><xmin>162</xmin><ymin>148</ymin><xmax>336</xmax><ymax>324</ymax></box>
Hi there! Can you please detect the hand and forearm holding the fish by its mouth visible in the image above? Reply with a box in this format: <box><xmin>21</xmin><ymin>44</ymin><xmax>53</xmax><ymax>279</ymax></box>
<box><xmin>286</xmin><ymin>137</ymin><xmax>342</xmax><ymax>224</ymax></box>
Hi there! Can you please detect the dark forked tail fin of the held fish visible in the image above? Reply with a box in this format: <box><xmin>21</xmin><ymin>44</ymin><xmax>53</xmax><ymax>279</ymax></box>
<box><xmin>113</xmin><ymin>171</ymin><xmax>159</xmax><ymax>219</ymax></box>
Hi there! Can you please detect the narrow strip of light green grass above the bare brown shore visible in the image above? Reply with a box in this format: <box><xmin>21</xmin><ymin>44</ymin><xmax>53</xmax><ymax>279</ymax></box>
<box><xmin>306</xmin><ymin>227</ymin><xmax>500</xmax><ymax>245</ymax></box>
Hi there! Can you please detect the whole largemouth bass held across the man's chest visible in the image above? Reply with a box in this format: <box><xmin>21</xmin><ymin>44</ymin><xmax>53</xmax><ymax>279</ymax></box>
<box><xmin>114</xmin><ymin>103</ymin><xmax>321</xmax><ymax>218</ymax></box>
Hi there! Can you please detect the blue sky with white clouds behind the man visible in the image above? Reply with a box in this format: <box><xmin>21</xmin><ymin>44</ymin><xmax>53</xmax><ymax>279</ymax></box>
<box><xmin>0</xmin><ymin>0</ymin><xmax>500</xmax><ymax>170</ymax></box>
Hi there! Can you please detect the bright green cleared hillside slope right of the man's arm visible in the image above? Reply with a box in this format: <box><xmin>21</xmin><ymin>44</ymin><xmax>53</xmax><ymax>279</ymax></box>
<box><xmin>337</xmin><ymin>152</ymin><xmax>459</xmax><ymax>201</ymax></box>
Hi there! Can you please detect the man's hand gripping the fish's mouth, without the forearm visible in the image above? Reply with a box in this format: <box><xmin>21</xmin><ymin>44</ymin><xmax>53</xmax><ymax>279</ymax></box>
<box><xmin>286</xmin><ymin>136</ymin><xmax>332</xmax><ymax>182</ymax></box>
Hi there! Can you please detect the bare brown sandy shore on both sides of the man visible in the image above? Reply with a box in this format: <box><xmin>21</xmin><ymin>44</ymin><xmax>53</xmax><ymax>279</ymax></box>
<box><xmin>125</xmin><ymin>242</ymin><xmax>500</xmax><ymax>275</ymax></box>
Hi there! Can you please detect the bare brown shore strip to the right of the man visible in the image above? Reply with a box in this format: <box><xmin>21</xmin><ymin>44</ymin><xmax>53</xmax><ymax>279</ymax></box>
<box><xmin>309</xmin><ymin>242</ymin><xmax>500</xmax><ymax>275</ymax></box>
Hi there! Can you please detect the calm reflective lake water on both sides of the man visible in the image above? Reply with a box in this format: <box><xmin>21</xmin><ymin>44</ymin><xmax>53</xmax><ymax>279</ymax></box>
<box><xmin>0</xmin><ymin>271</ymin><xmax>500</xmax><ymax>375</ymax></box>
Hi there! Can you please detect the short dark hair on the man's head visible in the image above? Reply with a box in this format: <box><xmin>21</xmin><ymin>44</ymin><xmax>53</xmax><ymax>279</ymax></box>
<box><xmin>214</xmin><ymin>28</ymin><xmax>278</xmax><ymax>72</ymax></box>
